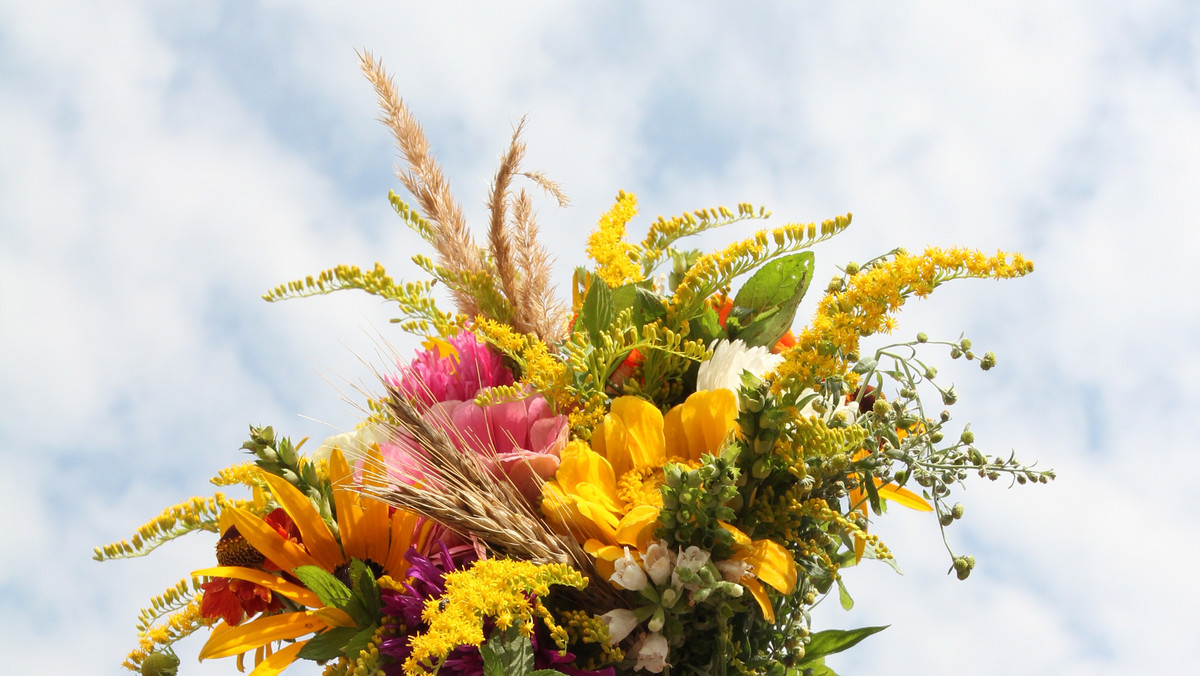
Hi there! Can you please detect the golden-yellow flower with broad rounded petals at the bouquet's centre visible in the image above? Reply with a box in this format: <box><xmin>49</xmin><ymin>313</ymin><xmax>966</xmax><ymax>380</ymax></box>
<box><xmin>541</xmin><ymin>389</ymin><xmax>738</xmax><ymax>573</ymax></box>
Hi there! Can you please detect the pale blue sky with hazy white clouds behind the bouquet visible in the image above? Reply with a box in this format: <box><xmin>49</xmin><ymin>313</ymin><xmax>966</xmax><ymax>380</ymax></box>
<box><xmin>0</xmin><ymin>0</ymin><xmax>1200</xmax><ymax>676</ymax></box>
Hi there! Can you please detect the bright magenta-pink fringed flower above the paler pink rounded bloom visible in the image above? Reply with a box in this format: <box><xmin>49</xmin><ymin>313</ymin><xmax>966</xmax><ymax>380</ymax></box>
<box><xmin>386</xmin><ymin>331</ymin><xmax>512</xmax><ymax>406</ymax></box>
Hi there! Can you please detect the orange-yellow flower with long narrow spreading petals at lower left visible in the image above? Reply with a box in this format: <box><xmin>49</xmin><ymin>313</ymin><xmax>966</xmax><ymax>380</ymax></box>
<box><xmin>192</xmin><ymin>448</ymin><xmax>432</xmax><ymax>676</ymax></box>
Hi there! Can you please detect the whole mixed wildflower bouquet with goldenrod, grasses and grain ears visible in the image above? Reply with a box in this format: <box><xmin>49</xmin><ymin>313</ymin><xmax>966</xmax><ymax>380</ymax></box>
<box><xmin>96</xmin><ymin>55</ymin><xmax>1054</xmax><ymax>676</ymax></box>
